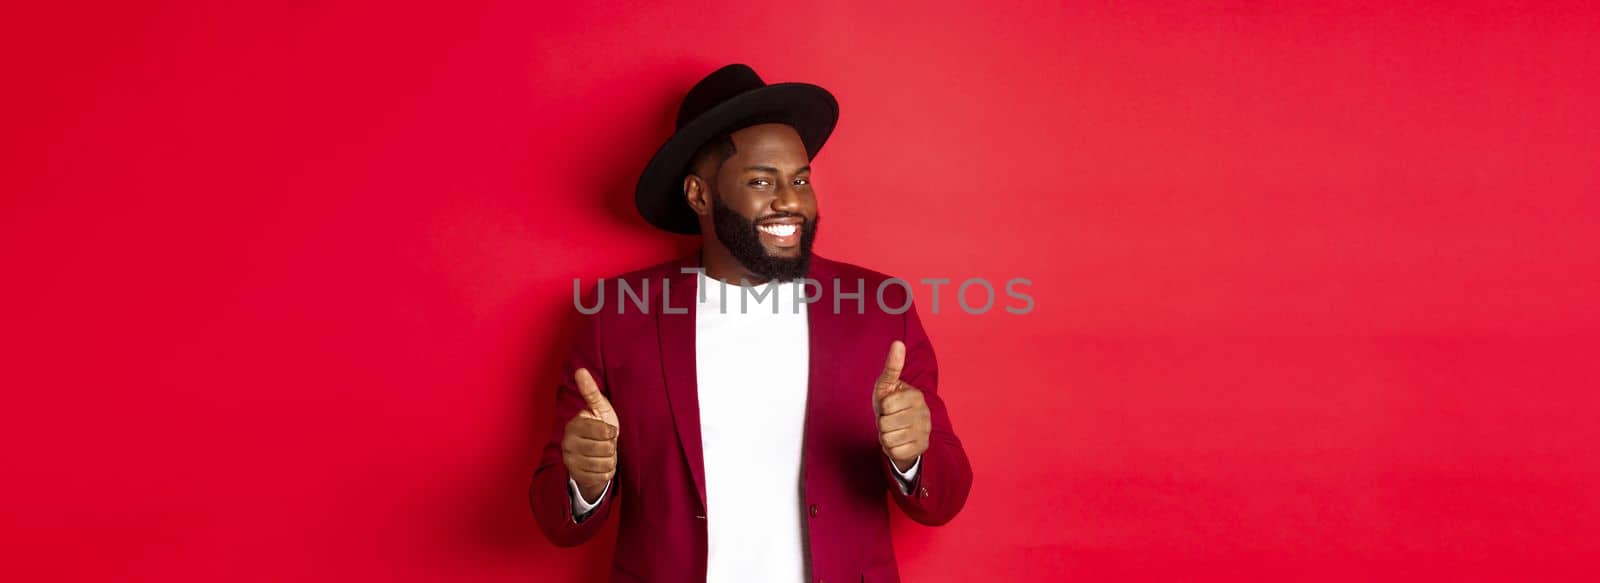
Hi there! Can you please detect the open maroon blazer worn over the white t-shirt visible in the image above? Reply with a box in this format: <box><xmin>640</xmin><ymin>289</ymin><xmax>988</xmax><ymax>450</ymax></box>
<box><xmin>528</xmin><ymin>255</ymin><xmax>973</xmax><ymax>581</ymax></box>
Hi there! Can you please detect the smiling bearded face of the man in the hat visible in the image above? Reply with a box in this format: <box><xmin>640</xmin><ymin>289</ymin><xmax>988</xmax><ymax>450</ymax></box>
<box><xmin>688</xmin><ymin>123</ymin><xmax>818</xmax><ymax>280</ymax></box>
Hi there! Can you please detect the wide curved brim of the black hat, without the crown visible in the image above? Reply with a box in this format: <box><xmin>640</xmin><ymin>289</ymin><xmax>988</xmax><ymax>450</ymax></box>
<box><xmin>634</xmin><ymin>83</ymin><xmax>838</xmax><ymax>234</ymax></box>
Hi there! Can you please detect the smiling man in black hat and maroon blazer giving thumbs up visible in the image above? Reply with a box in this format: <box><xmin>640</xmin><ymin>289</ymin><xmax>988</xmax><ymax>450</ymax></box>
<box><xmin>528</xmin><ymin>64</ymin><xmax>971</xmax><ymax>581</ymax></box>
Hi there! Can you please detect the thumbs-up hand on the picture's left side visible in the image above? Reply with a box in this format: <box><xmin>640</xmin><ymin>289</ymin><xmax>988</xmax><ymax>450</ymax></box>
<box><xmin>562</xmin><ymin>368</ymin><xmax>621</xmax><ymax>500</ymax></box>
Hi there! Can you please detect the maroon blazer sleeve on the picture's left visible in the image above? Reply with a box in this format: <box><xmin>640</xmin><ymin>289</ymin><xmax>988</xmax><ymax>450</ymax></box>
<box><xmin>528</xmin><ymin>305</ymin><xmax>621</xmax><ymax>546</ymax></box>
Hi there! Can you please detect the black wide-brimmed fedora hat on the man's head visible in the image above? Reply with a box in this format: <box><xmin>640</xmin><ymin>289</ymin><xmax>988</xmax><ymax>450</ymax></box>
<box><xmin>634</xmin><ymin>64</ymin><xmax>838</xmax><ymax>234</ymax></box>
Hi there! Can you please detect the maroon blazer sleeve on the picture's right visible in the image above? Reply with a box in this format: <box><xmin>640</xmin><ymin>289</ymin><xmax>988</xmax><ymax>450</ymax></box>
<box><xmin>878</xmin><ymin>306</ymin><xmax>973</xmax><ymax>525</ymax></box>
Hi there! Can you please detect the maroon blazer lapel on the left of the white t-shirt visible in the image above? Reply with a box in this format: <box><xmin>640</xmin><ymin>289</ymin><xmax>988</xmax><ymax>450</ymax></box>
<box><xmin>656</xmin><ymin>253</ymin><xmax>706</xmax><ymax>509</ymax></box>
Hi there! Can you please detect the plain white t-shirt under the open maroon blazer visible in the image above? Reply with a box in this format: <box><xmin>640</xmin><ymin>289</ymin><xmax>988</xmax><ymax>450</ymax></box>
<box><xmin>694</xmin><ymin>275</ymin><xmax>811</xmax><ymax>583</ymax></box>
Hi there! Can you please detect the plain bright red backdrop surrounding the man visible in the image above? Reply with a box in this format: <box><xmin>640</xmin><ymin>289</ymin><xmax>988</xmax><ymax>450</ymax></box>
<box><xmin>0</xmin><ymin>2</ymin><xmax>1600</xmax><ymax>581</ymax></box>
